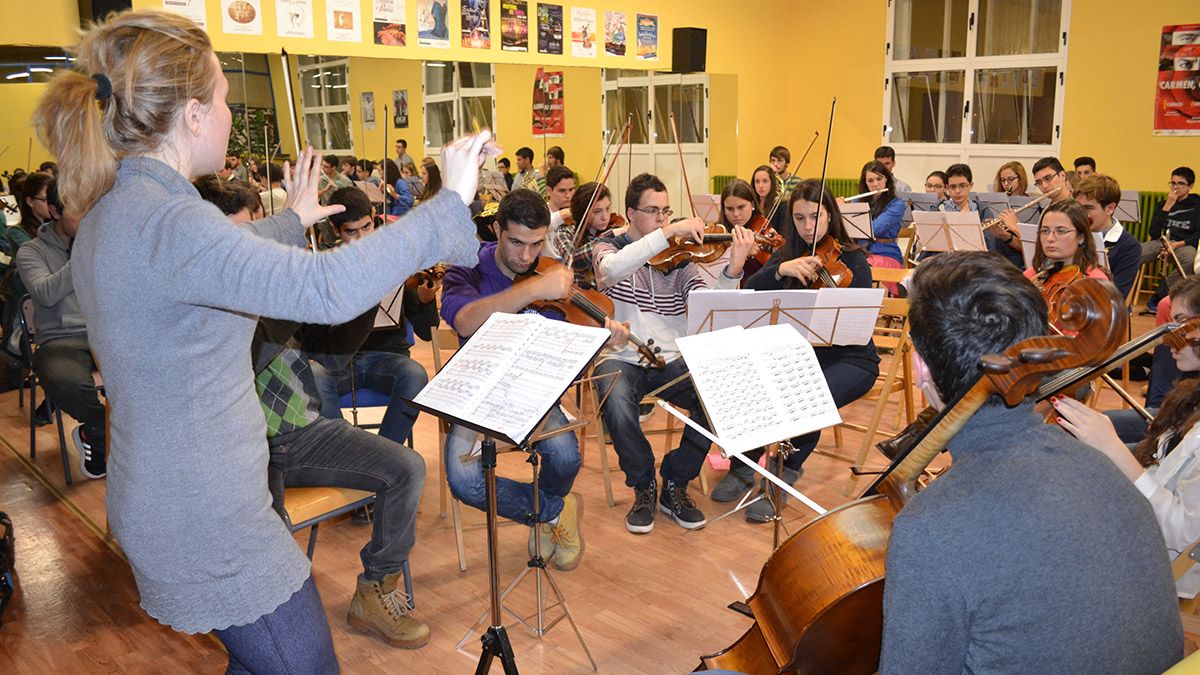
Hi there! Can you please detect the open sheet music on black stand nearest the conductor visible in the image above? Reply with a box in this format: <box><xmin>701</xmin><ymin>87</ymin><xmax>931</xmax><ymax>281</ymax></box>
<box><xmin>413</xmin><ymin>312</ymin><xmax>610</xmax><ymax>444</ymax></box>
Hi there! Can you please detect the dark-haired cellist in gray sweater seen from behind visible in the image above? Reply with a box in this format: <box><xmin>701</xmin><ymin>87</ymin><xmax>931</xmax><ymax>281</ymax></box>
<box><xmin>880</xmin><ymin>252</ymin><xmax>1183</xmax><ymax>674</ymax></box>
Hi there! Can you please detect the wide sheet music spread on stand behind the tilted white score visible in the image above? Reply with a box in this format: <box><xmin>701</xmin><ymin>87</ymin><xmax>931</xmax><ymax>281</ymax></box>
<box><xmin>688</xmin><ymin>288</ymin><xmax>886</xmax><ymax>347</ymax></box>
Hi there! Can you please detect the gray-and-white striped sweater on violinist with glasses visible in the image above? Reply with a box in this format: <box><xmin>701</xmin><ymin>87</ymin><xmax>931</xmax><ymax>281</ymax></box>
<box><xmin>593</xmin><ymin>229</ymin><xmax>742</xmax><ymax>363</ymax></box>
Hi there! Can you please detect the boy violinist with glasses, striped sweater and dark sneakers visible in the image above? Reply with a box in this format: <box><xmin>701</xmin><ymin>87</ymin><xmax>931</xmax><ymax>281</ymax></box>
<box><xmin>593</xmin><ymin>173</ymin><xmax>754</xmax><ymax>534</ymax></box>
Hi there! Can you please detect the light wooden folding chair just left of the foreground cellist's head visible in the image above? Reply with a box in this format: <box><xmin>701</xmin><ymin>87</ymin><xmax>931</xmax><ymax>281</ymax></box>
<box><xmin>834</xmin><ymin>298</ymin><xmax>917</xmax><ymax>495</ymax></box>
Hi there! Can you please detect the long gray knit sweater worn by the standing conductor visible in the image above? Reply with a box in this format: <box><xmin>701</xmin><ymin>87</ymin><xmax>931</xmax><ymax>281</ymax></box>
<box><xmin>72</xmin><ymin>159</ymin><xmax>478</xmax><ymax>632</ymax></box>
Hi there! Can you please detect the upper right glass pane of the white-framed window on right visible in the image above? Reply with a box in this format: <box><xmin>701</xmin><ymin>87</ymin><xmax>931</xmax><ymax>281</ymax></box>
<box><xmin>976</xmin><ymin>0</ymin><xmax>1062</xmax><ymax>56</ymax></box>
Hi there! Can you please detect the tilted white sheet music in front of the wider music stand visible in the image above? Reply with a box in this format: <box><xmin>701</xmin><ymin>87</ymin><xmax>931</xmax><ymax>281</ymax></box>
<box><xmin>676</xmin><ymin>324</ymin><xmax>841</xmax><ymax>455</ymax></box>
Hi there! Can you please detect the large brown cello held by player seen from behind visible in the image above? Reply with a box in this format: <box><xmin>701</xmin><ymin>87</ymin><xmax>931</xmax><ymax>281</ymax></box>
<box><xmin>701</xmin><ymin>279</ymin><xmax>1128</xmax><ymax>675</ymax></box>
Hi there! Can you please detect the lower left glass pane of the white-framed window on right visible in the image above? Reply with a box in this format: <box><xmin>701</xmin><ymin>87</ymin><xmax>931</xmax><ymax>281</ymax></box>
<box><xmin>890</xmin><ymin>71</ymin><xmax>966</xmax><ymax>143</ymax></box>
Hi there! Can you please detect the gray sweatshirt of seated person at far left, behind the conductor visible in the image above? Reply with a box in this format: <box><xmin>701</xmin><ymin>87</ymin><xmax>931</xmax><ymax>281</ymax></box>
<box><xmin>17</xmin><ymin>222</ymin><xmax>88</xmax><ymax>345</ymax></box>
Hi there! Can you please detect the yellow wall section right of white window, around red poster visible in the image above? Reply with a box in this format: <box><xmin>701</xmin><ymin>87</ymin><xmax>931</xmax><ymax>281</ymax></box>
<box><xmin>1062</xmin><ymin>0</ymin><xmax>1200</xmax><ymax>191</ymax></box>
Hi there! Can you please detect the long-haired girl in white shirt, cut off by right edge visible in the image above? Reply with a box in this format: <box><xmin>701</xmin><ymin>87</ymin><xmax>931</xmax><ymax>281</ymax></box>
<box><xmin>1054</xmin><ymin>279</ymin><xmax>1200</xmax><ymax>598</ymax></box>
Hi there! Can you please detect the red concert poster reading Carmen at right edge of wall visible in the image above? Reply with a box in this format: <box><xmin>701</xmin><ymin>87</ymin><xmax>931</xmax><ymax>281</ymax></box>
<box><xmin>1154</xmin><ymin>23</ymin><xmax>1200</xmax><ymax>136</ymax></box>
